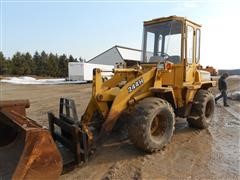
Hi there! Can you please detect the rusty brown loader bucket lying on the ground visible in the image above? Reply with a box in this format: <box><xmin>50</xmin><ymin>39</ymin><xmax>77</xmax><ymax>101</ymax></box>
<box><xmin>0</xmin><ymin>100</ymin><xmax>62</xmax><ymax>179</ymax></box>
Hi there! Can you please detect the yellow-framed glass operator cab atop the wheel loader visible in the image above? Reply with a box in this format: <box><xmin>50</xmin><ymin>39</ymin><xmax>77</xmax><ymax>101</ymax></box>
<box><xmin>142</xmin><ymin>16</ymin><xmax>201</xmax><ymax>83</ymax></box>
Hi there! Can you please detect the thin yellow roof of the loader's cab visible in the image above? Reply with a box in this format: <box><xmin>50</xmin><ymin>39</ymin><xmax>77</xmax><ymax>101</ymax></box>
<box><xmin>144</xmin><ymin>16</ymin><xmax>201</xmax><ymax>27</ymax></box>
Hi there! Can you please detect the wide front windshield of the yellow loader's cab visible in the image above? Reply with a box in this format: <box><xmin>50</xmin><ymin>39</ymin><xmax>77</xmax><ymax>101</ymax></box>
<box><xmin>143</xmin><ymin>17</ymin><xmax>183</xmax><ymax>64</ymax></box>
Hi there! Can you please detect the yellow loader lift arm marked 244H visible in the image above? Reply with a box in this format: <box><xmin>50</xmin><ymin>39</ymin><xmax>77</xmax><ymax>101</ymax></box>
<box><xmin>87</xmin><ymin>67</ymin><xmax>156</xmax><ymax>132</ymax></box>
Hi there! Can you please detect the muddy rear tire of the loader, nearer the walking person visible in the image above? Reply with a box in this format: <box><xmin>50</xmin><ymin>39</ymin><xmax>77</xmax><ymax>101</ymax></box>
<box><xmin>187</xmin><ymin>89</ymin><xmax>215</xmax><ymax>129</ymax></box>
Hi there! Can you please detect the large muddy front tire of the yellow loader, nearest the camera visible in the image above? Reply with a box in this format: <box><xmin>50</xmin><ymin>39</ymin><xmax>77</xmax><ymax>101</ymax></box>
<box><xmin>128</xmin><ymin>97</ymin><xmax>175</xmax><ymax>153</ymax></box>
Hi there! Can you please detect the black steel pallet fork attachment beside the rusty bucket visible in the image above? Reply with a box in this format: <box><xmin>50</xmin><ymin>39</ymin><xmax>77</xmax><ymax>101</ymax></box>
<box><xmin>48</xmin><ymin>98</ymin><xmax>90</xmax><ymax>170</ymax></box>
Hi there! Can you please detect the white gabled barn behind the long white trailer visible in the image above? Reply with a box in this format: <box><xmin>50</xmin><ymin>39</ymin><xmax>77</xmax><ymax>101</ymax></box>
<box><xmin>88</xmin><ymin>45</ymin><xmax>142</xmax><ymax>66</ymax></box>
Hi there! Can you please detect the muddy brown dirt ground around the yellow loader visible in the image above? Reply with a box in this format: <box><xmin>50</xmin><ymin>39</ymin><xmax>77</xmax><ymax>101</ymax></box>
<box><xmin>0</xmin><ymin>76</ymin><xmax>240</xmax><ymax>180</ymax></box>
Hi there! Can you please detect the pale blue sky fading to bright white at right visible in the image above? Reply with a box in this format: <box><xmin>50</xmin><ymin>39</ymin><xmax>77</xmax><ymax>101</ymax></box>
<box><xmin>0</xmin><ymin>0</ymin><xmax>240</xmax><ymax>69</ymax></box>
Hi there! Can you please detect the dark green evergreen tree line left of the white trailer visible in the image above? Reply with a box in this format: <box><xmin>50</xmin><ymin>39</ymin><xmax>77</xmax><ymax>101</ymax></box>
<box><xmin>0</xmin><ymin>51</ymin><xmax>85</xmax><ymax>77</ymax></box>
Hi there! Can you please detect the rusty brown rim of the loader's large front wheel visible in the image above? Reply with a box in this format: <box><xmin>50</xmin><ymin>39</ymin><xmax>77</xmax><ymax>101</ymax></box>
<box><xmin>151</xmin><ymin>114</ymin><xmax>167</xmax><ymax>138</ymax></box>
